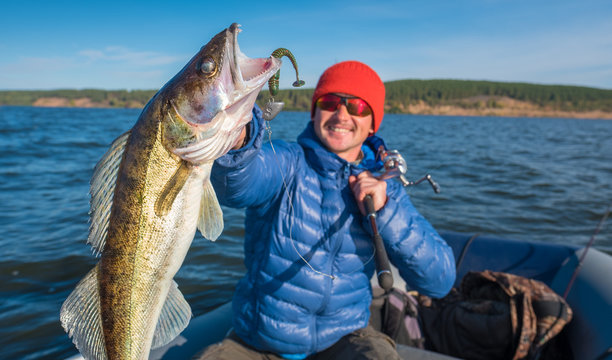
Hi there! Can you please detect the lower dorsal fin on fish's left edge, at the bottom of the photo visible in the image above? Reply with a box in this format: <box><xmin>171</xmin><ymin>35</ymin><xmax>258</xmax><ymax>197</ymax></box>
<box><xmin>60</xmin><ymin>266</ymin><xmax>106</xmax><ymax>359</ymax></box>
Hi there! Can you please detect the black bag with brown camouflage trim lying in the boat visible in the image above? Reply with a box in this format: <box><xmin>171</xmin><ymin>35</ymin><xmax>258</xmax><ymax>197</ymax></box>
<box><xmin>418</xmin><ymin>270</ymin><xmax>572</xmax><ymax>360</ymax></box>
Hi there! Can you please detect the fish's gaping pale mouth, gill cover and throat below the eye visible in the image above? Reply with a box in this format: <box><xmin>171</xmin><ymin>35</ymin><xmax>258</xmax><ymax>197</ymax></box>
<box><xmin>167</xmin><ymin>24</ymin><xmax>282</xmax><ymax>163</ymax></box>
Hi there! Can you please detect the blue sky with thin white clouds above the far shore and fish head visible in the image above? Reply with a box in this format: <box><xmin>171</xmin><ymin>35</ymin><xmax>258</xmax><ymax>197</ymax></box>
<box><xmin>0</xmin><ymin>0</ymin><xmax>612</xmax><ymax>90</ymax></box>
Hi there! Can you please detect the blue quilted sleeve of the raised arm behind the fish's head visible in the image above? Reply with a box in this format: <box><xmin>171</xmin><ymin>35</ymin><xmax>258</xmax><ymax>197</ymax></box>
<box><xmin>211</xmin><ymin>106</ymin><xmax>298</xmax><ymax>208</ymax></box>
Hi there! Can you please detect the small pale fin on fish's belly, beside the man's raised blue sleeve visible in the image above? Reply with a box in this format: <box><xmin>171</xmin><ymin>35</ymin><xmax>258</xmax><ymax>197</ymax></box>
<box><xmin>198</xmin><ymin>163</ymin><xmax>223</xmax><ymax>241</ymax></box>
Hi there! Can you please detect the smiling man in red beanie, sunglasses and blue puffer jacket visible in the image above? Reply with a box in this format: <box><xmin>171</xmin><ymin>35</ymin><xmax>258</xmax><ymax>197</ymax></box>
<box><xmin>203</xmin><ymin>61</ymin><xmax>455</xmax><ymax>360</ymax></box>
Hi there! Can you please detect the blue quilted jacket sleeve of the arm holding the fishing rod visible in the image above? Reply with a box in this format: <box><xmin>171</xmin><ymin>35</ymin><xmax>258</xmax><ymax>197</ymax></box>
<box><xmin>376</xmin><ymin>182</ymin><xmax>456</xmax><ymax>298</ymax></box>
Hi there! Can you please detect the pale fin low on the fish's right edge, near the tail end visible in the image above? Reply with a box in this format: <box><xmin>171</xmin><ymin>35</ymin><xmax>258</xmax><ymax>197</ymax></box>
<box><xmin>151</xmin><ymin>281</ymin><xmax>191</xmax><ymax>349</ymax></box>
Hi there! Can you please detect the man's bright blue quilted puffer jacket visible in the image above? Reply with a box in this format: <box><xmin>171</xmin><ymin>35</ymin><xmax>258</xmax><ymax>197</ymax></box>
<box><xmin>211</xmin><ymin>108</ymin><xmax>455</xmax><ymax>354</ymax></box>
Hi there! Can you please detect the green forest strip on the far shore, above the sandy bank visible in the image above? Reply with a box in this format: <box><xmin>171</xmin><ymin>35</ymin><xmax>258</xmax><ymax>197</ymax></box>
<box><xmin>0</xmin><ymin>80</ymin><xmax>612</xmax><ymax>113</ymax></box>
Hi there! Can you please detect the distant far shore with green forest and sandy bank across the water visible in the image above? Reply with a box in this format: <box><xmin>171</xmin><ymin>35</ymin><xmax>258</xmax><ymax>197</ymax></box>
<box><xmin>0</xmin><ymin>80</ymin><xmax>612</xmax><ymax>118</ymax></box>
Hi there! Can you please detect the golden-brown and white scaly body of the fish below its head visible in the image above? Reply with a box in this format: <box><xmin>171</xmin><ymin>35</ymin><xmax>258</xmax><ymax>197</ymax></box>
<box><xmin>99</xmin><ymin>111</ymin><xmax>202</xmax><ymax>358</ymax></box>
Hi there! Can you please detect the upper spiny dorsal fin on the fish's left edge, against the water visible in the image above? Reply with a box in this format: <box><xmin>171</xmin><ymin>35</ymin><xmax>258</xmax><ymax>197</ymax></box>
<box><xmin>87</xmin><ymin>131</ymin><xmax>130</xmax><ymax>254</ymax></box>
